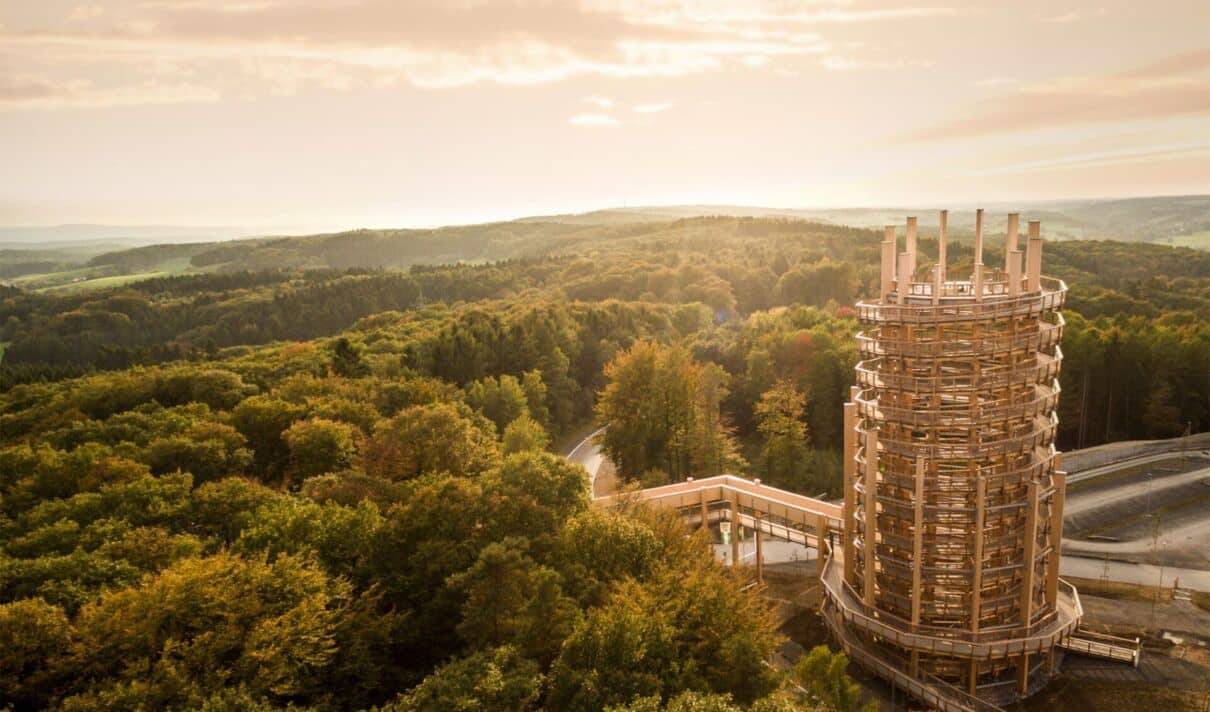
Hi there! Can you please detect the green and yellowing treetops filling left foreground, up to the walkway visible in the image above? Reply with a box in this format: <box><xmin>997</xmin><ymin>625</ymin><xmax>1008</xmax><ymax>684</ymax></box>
<box><xmin>0</xmin><ymin>293</ymin><xmax>861</xmax><ymax>711</ymax></box>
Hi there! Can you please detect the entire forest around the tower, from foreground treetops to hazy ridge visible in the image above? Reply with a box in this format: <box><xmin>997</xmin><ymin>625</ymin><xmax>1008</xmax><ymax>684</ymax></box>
<box><xmin>0</xmin><ymin>218</ymin><xmax>1210</xmax><ymax>712</ymax></box>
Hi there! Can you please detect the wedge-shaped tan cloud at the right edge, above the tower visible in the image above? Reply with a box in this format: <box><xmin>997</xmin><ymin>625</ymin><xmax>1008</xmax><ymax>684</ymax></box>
<box><xmin>898</xmin><ymin>48</ymin><xmax>1210</xmax><ymax>142</ymax></box>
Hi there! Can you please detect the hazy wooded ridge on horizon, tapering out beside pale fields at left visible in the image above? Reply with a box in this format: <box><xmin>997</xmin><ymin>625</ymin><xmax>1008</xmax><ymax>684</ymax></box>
<box><xmin>170</xmin><ymin>196</ymin><xmax>1210</xmax><ymax>270</ymax></box>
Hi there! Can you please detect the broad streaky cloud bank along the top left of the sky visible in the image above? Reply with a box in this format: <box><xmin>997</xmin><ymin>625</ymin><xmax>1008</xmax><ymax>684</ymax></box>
<box><xmin>0</xmin><ymin>0</ymin><xmax>955</xmax><ymax>108</ymax></box>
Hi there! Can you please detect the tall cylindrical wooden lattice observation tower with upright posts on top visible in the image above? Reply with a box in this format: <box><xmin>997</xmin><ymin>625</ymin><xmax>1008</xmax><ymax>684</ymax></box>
<box><xmin>823</xmin><ymin>211</ymin><xmax>1081</xmax><ymax>708</ymax></box>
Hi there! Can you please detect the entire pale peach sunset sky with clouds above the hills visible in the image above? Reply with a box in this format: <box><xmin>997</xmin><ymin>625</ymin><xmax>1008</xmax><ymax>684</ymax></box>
<box><xmin>0</xmin><ymin>0</ymin><xmax>1210</xmax><ymax>230</ymax></box>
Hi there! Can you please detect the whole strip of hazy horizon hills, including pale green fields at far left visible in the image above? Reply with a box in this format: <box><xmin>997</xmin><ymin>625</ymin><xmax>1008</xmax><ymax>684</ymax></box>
<box><xmin>7</xmin><ymin>195</ymin><xmax>1210</xmax><ymax>291</ymax></box>
